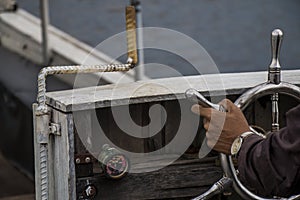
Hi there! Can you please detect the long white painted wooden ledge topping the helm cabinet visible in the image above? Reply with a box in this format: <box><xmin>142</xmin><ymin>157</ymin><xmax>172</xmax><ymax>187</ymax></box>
<box><xmin>47</xmin><ymin>70</ymin><xmax>300</xmax><ymax>112</ymax></box>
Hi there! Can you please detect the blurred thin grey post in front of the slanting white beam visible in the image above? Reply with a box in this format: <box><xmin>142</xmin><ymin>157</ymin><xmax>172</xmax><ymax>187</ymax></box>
<box><xmin>40</xmin><ymin>0</ymin><xmax>50</xmax><ymax>66</ymax></box>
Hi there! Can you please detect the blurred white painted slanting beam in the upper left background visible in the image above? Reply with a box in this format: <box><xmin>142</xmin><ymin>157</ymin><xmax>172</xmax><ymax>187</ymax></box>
<box><xmin>0</xmin><ymin>9</ymin><xmax>134</xmax><ymax>84</ymax></box>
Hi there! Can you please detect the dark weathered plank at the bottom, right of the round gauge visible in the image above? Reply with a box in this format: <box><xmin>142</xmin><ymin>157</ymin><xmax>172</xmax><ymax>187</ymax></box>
<box><xmin>78</xmin><ymin>157</ymin><xmax>222</xmax><ymax>200</ymax></box>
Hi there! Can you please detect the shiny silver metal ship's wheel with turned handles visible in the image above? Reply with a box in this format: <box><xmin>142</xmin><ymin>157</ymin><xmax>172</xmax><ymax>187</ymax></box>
<box><xmin>186</xmin><ymin>29</ymin><xmax>300</xmax><ymax>200</ymax></box>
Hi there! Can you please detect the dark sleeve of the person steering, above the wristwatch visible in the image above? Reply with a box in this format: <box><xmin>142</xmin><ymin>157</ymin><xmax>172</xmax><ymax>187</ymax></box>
<box><xmin>238</xmin><ymin>105</ymin><xmax>300</xmax><ymax>197</ymax></box>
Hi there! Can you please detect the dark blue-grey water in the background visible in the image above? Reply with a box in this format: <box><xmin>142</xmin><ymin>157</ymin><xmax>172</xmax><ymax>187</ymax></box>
<box><xmin>18</xmin><ymin>0</ymin><xmax>300</xmax><ymax>77</ymax></box>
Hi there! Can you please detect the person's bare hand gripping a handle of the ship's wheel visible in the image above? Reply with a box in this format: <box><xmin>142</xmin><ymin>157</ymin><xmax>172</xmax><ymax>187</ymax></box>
<box><xmin>191</xmin><ymin>99</ymin><xmax>250</xmax><ymax>155</ymax></box>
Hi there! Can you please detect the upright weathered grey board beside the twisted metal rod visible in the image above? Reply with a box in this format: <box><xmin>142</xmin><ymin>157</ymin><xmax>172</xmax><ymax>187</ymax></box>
<box><xmin>48</xmin><ymin>110</ymin><xmax>76</xmax><ymax>199</ymax></box>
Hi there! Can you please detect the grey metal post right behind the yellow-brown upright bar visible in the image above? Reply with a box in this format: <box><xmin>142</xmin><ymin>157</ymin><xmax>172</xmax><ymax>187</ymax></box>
<box><xmin>130</xmin><ymin>0</ymin><xmax>144</xmax><ymax>81</ymax></box>
